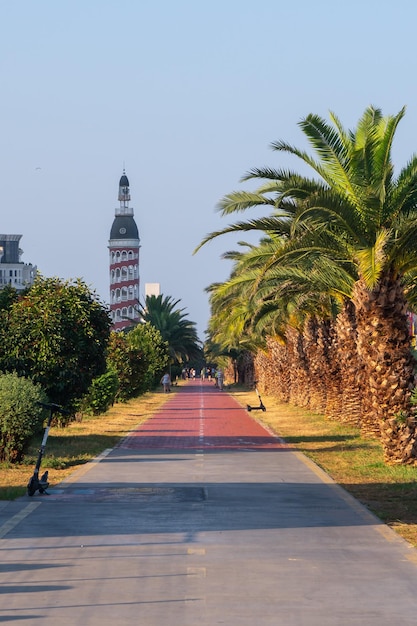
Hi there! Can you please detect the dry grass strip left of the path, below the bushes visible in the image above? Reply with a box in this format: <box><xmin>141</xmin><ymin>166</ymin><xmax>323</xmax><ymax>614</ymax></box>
<box><xmin>0</xmin><ymin>388</ymin><xmax>175</xmax><ymax>500</ymax></box>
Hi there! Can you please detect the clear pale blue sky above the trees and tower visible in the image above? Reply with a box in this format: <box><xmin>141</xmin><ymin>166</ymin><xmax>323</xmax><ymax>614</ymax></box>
<box><xmin>0</xmin><ymin>0</ymin><xmax>417</xmax><ymax>338</ymax></box>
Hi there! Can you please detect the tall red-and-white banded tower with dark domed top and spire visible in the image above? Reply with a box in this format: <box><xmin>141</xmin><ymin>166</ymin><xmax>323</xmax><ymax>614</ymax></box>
<box><xmin>109</xmin><ymin>170</ymin><xmax>140</xmax><ymax>330</ymax></box>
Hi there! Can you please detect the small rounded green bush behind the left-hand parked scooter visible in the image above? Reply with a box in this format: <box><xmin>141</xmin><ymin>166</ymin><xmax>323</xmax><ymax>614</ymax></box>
<box><xmin>0</xmin><ymin>373</ymin><xmax>47</xmax><ymax>463</ymax></box>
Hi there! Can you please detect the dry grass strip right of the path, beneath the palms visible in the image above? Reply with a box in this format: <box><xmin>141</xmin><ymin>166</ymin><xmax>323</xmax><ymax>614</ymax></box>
<box><xmin>230</xmin><ymin>388</ymin><xmax>417</xmax><ymax>547</ymax></box>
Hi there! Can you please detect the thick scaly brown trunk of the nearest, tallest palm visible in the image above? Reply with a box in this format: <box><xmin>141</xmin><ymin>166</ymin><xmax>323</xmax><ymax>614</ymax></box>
<box><xmin>353</xmin><ymin>272</ymin><xmax>417</xmax><ymax>463</ymax></box>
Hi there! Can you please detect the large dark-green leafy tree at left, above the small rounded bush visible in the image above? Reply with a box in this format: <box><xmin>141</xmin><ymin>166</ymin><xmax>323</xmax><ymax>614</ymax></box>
<box><xmin>0</xmin><ymin>277</ymin><xmax>111</xmax><ymax>408</ymax></box>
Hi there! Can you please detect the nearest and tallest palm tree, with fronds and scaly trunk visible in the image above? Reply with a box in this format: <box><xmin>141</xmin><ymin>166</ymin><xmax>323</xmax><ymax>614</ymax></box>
<box><xmin>197</xmin><ymin>107</ymin><xmax>417</xmax><ymax>462</ymax></box>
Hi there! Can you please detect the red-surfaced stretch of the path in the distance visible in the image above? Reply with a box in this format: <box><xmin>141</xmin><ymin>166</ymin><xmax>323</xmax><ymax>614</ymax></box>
<box><xmin>119</xmin><ymin>379</ymin><xmax>285</xmax><ymax>452</ymax></box>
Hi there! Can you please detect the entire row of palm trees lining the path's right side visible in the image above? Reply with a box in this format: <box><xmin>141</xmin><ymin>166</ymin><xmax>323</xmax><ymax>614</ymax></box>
<box><xmin>199</xmin><ymin>106</ymin><xmax>417</xmax><ymax>463</ymax></box>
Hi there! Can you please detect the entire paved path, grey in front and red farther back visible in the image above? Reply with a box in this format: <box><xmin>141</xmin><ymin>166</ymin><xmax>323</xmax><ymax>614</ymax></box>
<box><xmin>0</xmin><ymin>380</ymin><xmax>417</xmax><ymax>626</ymax></box>
